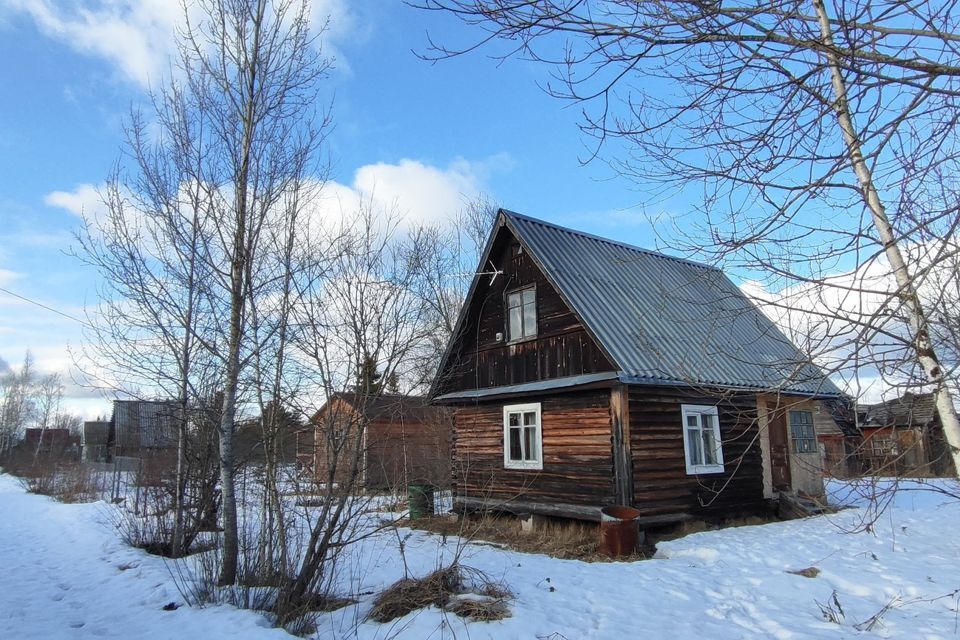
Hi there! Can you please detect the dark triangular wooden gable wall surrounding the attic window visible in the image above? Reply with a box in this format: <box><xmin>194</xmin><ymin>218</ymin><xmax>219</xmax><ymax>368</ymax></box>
<box><xmin>438</xmin><ymin>227</ymin><xmax>613</xmax><ymax>394</ymax></box>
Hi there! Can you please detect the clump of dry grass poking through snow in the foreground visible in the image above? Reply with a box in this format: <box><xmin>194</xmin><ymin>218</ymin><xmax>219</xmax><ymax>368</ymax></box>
<box><xmin>367</xmin><ymin>564</ymin><xmax>513</xmax><ymax>623</ymax></box>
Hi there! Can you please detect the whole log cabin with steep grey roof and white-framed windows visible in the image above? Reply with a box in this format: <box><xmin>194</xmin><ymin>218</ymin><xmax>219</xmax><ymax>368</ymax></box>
<box><xmin>431</xmin><ymin>210</ymin><xmax>840</xmax><ymax>525</ymax></box>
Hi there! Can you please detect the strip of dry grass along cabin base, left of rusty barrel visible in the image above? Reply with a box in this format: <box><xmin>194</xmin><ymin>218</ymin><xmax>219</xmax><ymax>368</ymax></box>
<box><xmin>401</xmin><ymin>513</ymin><xmax>652</xmax><ymax>562</ymax></box>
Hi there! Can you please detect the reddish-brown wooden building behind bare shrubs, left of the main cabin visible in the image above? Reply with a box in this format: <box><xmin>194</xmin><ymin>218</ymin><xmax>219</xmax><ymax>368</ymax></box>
<box><xmin>297</xmin><ymin>393</ymin><xmax>451</xmax><ymax>489</ymax></box>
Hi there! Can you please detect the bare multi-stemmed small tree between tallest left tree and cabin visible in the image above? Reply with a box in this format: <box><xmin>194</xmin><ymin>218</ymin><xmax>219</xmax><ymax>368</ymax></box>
<box><xmin>274</xmin><ymin>204</ymin><xmax>434</xmax><ymax>625</ymax></box>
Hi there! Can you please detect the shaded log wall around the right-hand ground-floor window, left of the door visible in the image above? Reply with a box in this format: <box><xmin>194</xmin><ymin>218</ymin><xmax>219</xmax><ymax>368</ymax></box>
<box><xmin>629</xmin><ymin>386</ymin><xmax>764</xmax><ymax>517</ymax></box>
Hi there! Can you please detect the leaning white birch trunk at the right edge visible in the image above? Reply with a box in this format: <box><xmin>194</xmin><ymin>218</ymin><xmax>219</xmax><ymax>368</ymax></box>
<box><xmin>811</xmin><ymin>0</ymin><xmax>960</xmax><ymax>477</ymax></box>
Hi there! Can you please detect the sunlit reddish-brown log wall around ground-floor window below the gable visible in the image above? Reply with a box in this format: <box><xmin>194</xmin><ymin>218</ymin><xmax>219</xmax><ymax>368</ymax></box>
<box><xmin>453</xmin><ymin>390</ymin><xmax>615</xmax><ymax>507</ymax></box>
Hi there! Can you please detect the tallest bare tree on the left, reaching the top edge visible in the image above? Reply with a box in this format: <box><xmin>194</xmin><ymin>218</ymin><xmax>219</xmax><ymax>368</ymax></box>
<box><xmin>166</xmin><ymin>0</ymin><xmax>330</xmax><ymax>584</ymax></box>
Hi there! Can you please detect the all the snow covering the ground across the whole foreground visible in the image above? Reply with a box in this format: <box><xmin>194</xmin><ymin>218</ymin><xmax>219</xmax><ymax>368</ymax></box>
<box><xmin>0</xmin><ymin>475</ymin><xmax>960</xmax><ymax>640</ymax></box>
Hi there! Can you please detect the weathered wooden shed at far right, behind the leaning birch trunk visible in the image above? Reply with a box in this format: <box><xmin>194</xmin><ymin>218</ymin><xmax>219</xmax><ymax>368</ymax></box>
<box><xmin>857</xmin><ymin>393</ymin><xmax>953</xmax><ymax>476</ymax></box>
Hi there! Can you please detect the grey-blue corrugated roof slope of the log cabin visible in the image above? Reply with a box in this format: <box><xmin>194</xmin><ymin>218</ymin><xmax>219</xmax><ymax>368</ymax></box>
<box><xmin>501</xmin><ymin>210</ymin><xmax>840</xmax><ymax>395</ymax></box>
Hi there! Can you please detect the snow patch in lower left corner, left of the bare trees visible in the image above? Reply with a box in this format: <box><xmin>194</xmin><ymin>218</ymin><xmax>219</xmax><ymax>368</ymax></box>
<box><xmin>0</xmin><ymin>474</ymin><xmax>290</xmax><ymax>640</ymax></box>
